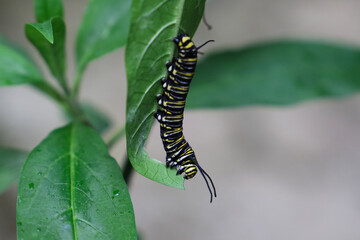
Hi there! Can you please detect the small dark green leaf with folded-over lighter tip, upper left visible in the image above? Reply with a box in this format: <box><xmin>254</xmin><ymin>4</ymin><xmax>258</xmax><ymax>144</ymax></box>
<box><xmin>25</xmin><ymin>17</ymin><xmax>66</xmax><ymax>88</ymax></box>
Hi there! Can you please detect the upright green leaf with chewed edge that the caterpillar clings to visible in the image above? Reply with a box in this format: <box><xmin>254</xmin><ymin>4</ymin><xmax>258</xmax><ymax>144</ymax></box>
<box><xmin>125</xmin><ymin>0</ymin><xmax>205</xmax><ymax>188</ymax></box>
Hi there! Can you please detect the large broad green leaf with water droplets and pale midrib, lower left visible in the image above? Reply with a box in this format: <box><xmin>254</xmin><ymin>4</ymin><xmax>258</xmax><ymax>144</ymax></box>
<box><xmin>17</xmin><ymin>123</ymin><xmax>136</xmax><ymax>240</ymax></box>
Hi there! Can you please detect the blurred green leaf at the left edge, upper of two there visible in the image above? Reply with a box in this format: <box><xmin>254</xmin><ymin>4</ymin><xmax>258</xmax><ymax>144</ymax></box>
<box><xmin>0</xmin><ymin>36</ymin><xmax>44</xmax><ymax>86</ymax></box>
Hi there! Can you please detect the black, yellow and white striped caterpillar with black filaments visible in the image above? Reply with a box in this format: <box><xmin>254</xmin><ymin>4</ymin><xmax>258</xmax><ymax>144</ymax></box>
<box><xmin>154</xmin><ymin>34</ymin><xmax>216</xmax><ymax>202</ymax></box>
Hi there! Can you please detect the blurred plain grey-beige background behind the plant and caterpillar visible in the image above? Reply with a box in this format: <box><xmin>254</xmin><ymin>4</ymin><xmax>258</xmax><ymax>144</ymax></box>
<box><xmin>0</xmin><ymin>0</ymin><xmax>360</xmax><ymax>240</ymax></box>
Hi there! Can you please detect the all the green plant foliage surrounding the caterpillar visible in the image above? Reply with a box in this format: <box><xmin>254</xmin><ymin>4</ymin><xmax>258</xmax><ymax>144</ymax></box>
<box><xmin>0</xmin><ymin>0</ymin><xmax>360</xmax><ymax>239</ymax></box>
